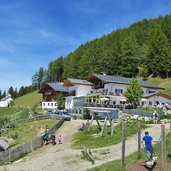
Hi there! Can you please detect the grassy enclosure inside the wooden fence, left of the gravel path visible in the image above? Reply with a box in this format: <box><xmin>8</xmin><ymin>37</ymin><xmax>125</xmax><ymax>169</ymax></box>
<box><xmin>2</xmin><ymin>119</ymin><xmax>58</xmax><ymax>146</ymax></box>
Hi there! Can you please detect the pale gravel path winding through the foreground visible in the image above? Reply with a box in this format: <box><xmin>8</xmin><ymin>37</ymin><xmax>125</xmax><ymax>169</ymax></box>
<box><xmin>0</xmin><ymin>120</ymin><xmax>169</xmax><ymax>171</ymax></box>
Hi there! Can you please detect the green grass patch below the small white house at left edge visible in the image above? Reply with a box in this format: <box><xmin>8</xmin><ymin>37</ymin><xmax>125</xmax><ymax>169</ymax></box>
<box><xmin>0</xmin><ymin>107</ymin><xmax>29</xmax><ymax>121</ymax></box>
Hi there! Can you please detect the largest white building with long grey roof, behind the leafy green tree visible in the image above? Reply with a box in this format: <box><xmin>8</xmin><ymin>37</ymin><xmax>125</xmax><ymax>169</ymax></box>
<box><xmin>88</xmin><ymin>74</ymin><xmax>162</xmax><ymax>105</ymax></box>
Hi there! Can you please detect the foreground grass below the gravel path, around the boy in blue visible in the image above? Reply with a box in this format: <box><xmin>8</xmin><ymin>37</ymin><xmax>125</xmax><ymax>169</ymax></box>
<box><xmin>88</xmin><ymin>130</ymin><xmax>171</xmax><ymax>171</ymax></box>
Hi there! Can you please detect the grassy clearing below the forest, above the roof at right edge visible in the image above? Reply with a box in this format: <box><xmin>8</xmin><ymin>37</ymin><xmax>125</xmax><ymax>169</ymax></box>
<box><xmin>147</xmin><ymin>77</ymin><xmax>171</xmax><ymax>95</ymax></box>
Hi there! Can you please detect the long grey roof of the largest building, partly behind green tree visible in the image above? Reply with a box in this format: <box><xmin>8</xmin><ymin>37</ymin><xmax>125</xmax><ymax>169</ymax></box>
<box><xmin>90</xmin><ymin>74</ymin><xmax>163</xmax><ymax>89</ymax></box>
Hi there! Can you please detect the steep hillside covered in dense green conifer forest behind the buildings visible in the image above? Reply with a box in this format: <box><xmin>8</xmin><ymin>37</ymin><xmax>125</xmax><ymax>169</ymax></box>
<box><xmin>32</xmin><ymin>15</ymin><xmax>171</xmax><ymax>86</ymax></box>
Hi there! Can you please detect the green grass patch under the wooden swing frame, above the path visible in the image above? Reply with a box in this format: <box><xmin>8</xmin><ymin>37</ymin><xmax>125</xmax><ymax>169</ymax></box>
<box><xmin>72</xmin><ymin>123</ymin><xmax>146</xmax><ymax>148</ymax></box>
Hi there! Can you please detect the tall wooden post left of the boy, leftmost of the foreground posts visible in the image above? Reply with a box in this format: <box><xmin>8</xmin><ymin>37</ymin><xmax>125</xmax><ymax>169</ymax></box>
<box><xmin>121</xmin><ymin>122</ymin><xmax>126</xmax><ymax>168</ymax></box>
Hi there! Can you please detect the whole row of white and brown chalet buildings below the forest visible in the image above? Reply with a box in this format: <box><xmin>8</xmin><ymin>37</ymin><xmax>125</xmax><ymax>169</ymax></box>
<box><xmin>39</xmin><ymin>74</ymin><xmax>166</xmax><ymax>113</ymax></box>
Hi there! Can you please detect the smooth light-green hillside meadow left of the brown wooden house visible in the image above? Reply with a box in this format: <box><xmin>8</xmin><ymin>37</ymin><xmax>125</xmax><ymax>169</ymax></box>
<box><xmin>14</xmin><ymin>91</ymin><xmax>42</xmax><ymax>108</ymax></box>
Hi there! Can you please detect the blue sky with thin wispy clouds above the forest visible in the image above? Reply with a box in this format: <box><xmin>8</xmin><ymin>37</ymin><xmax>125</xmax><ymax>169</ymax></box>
<box><xmin>0</xmin><ymin>0</ymin><xmax>171</xmax><ymax>90</ymax></box>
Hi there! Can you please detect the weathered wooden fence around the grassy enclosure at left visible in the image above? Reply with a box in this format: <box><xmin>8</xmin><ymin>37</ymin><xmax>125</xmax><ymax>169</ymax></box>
<box><xmin>0</xmin><ymin>116</ymin><xmax>64</xmax><ymax>162</ymax></box>
